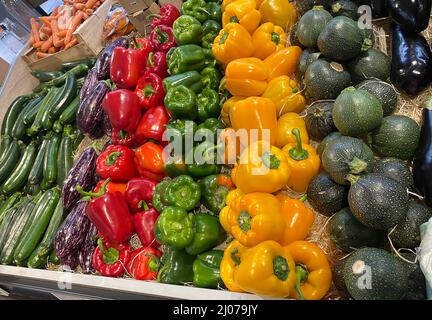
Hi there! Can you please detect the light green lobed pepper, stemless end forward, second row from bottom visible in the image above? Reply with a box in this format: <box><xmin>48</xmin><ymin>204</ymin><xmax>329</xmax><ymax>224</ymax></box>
<box><xmin>154</xmin><ymin>206</ymin><xmax>195</xmax><ymax>249</ymax></box>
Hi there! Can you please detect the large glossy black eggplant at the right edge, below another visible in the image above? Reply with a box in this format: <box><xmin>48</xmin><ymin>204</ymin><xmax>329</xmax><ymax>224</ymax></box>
<box><xmin>390</xmin><ymin>23</ymin><xmax>432</xmax><ymax>95</ymax></box>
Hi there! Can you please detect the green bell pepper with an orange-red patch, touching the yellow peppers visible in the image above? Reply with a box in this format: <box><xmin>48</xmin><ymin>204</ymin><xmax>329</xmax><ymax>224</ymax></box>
<box><xmin>199</xmin><ymin>174</ymin><xmax>232</xmax><ymax>214</ymax></box>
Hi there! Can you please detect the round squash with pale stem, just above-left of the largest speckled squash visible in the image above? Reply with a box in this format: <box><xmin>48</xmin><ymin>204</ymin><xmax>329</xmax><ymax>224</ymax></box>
<box><xmin>321</xmin><ymin>136</ymin><xmax>375</xmax><ymax>185</ymax></box>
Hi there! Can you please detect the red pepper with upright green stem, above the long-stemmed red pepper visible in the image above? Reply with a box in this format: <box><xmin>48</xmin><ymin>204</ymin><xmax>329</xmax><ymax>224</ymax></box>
<box><xmin>96</xmin><ymin>144</ymin><xmax>138</xmax><ymax>181</ymax></box>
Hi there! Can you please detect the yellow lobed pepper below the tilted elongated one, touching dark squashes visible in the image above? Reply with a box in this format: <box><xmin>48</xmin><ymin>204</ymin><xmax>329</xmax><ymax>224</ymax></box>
<box><xmin>262</xmin><ymin>76</ymin><xmax>306</xmax><ymax>117</ymax></box>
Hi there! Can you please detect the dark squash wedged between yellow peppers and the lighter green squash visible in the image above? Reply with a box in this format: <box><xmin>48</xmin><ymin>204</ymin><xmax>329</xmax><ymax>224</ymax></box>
<box><xmin>305</xmin><ymin>100</ymin><xmax>336</xmax><ymax>141</ymax></box>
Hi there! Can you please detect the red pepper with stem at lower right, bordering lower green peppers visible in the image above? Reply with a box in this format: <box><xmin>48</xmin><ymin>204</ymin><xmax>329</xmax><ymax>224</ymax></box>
<box><xmin>126</xmin><ymin>178</ymin><xmax>157</xmax><ymax>212</ymax></box>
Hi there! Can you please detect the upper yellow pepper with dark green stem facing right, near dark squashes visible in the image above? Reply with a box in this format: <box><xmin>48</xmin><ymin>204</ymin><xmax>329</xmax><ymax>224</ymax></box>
<box><xmin>252</xmin><ymin>22</ymin><xmax>287</xmax><ymax>59</ymax></box>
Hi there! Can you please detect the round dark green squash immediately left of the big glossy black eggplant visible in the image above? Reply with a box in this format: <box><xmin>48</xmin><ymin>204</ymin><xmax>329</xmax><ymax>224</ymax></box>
<box><xmin>347</xmin><ymin>49</ymin><xmax>391</xmax><ymax>84</ymax></box>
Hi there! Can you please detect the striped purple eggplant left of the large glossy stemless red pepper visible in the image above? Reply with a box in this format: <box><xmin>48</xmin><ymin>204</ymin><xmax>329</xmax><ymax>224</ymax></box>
<box><xmin>77</xmin><ymin>81</ymin><xmax>109</xmax><ymax>138</ymax></box>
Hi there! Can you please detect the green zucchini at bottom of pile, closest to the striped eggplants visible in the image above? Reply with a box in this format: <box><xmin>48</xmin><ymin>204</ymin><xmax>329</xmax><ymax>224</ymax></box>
<box><xmin>27</xmin><ymin>200</ymin><xmax>63</xmax><ymax>268</ymax></box>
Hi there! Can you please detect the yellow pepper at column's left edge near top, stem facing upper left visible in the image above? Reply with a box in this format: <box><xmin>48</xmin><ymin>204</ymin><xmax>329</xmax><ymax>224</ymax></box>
<box><xmin>212</xmin><ymin>23</ymin><xmax>254</xmax><ymax>65</ymax></box>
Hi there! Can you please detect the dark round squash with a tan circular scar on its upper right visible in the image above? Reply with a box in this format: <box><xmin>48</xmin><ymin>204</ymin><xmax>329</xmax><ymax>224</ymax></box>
<box><xmin>304</xmin><ymin>59</ymin><xmax>351</xmax><ymax>100</ymax></box>
